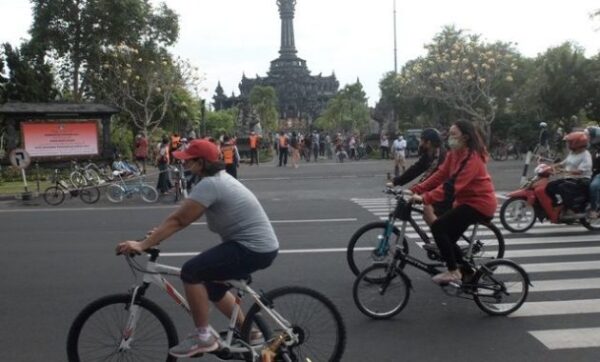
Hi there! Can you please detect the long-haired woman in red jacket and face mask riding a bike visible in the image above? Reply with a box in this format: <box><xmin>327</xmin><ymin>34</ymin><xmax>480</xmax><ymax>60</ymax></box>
<box><xmin>411</xmin><ymin>121</ymin><xmax>497</xmax><ymax>284</ymax></box>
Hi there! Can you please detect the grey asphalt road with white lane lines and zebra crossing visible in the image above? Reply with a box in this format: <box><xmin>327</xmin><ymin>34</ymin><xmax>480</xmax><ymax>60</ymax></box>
<box><xmin>0</xmin><ymin>161</ymin><xmax>600</xmax><ymax>362</ymax></box>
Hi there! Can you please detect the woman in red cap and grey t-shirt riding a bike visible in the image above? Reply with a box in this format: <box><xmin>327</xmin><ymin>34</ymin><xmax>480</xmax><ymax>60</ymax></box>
<box><xmin>117</xmin><ymin>140</ymin><xmax>279</xmax><ymax>358</ymax></box>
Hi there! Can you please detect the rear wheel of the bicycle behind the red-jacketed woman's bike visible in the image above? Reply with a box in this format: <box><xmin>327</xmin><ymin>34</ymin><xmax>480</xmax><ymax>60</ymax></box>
<box><xmin>462</xmin><ymin>222</ymin><xmax>505</xmax><ymax>259</ymax></box>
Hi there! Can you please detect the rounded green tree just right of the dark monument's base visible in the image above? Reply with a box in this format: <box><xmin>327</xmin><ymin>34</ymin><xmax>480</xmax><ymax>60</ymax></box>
<box><xmin>315</xmin><ymin>81</ymin><xmax>371</xmax><ymax>134</ymax></box>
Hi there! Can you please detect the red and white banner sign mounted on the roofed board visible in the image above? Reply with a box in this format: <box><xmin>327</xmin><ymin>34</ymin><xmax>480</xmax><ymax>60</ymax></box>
<box><xmin>21</xmin><ymin>120</ymin><xmax>98</xmax><ymax>157</ymax></box>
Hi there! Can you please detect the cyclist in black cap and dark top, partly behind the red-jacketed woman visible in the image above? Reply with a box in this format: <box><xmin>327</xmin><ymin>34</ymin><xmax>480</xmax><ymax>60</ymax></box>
<box><xmin>392</xmin><ymin>128</ymin><xmax>448</xmax><ymax>226</ymax></box>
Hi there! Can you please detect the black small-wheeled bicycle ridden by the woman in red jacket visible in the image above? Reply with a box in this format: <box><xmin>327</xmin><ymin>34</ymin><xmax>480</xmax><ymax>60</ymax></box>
<box><xmin>352</xmin><ymin>188</ymin><xmax>531</xmax><ymax>319</ymax></box>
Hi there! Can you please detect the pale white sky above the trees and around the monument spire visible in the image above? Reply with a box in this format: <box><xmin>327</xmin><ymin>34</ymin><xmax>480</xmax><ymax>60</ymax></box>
<box><xmin>0</xmin><ymin>0</ymin><xmax>600</xmax><ymax>106</ymax></box>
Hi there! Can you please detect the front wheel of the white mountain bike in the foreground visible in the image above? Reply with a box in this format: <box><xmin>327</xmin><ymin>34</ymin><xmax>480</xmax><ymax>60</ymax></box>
<box><xmin>67</xmin><ymin>294</ymin><xmax>178</xmax><ymax>362</ymax></box>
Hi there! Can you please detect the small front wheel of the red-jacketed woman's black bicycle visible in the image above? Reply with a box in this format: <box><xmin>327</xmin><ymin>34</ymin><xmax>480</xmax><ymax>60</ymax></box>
<box><xmin>352</xmin><ymin>264</ymin><xmax>410</xmax><ymax>319</ymax></box>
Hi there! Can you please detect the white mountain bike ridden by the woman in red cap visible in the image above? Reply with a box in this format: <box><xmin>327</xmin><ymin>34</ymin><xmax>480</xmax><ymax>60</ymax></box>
<box><xmin>67</xmin><ymin>249</ymin><xmax>346</xmax><ymax>362</ymax></box>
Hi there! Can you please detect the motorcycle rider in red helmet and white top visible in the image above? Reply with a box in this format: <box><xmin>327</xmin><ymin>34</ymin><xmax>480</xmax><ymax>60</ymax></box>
<box><xmin>546</xmin><ymin>131</ymin><xmax>592</xmax><ymax>212</ymax></box>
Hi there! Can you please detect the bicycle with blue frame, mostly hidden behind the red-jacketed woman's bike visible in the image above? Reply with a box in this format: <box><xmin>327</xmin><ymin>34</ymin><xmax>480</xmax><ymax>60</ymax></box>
<box><xmin>346</xmin><ymin>187</ymin><xmax>505</xmax><ymax>275</ymax></box>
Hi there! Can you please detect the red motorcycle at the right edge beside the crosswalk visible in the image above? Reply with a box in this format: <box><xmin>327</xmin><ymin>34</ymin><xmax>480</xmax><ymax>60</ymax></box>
<box><xmin>500</xmin><ymin>163</ymin><xmax>600</xmax><ymax>233</ymax></box>
